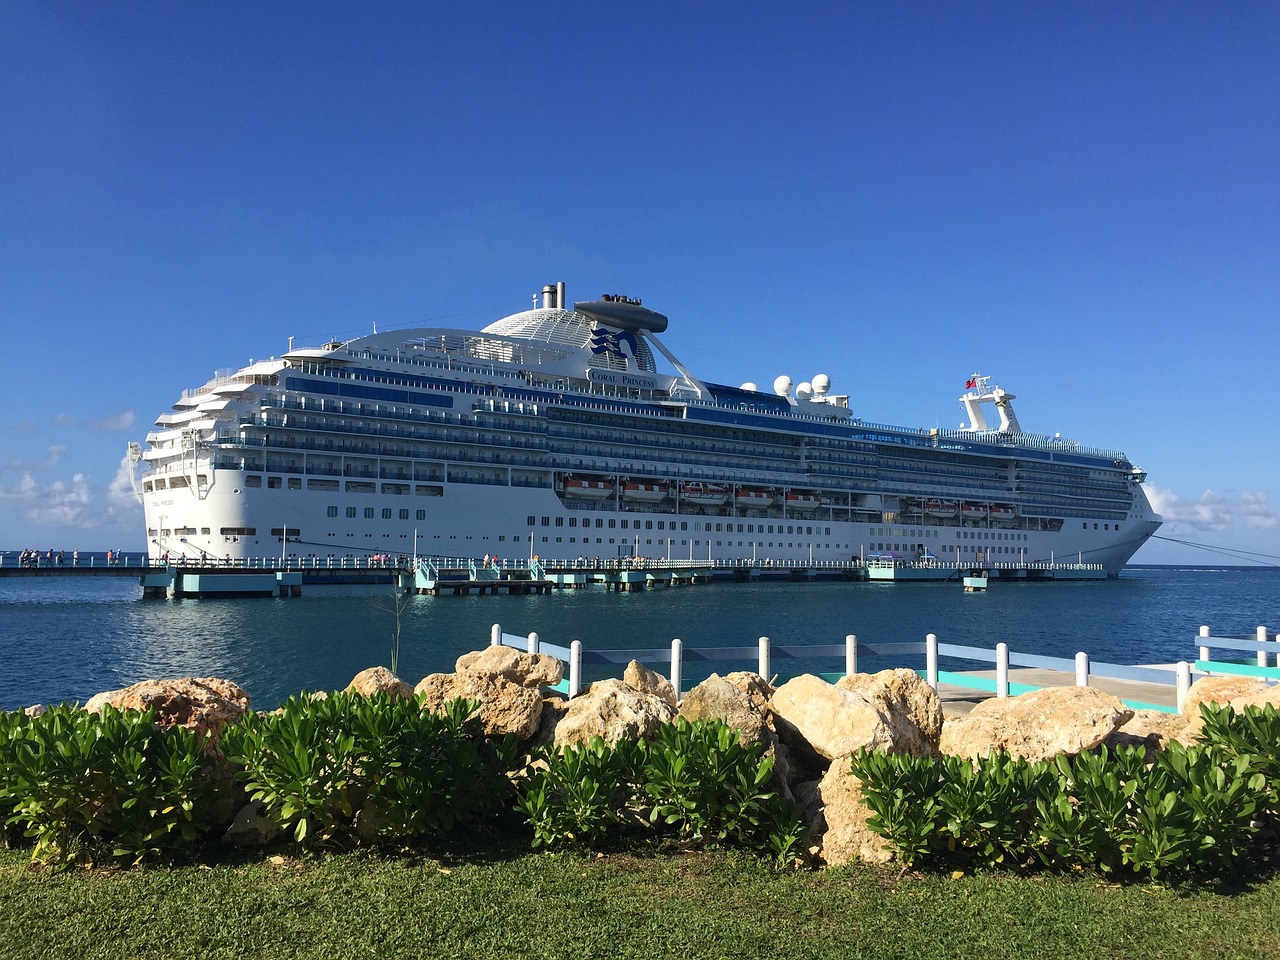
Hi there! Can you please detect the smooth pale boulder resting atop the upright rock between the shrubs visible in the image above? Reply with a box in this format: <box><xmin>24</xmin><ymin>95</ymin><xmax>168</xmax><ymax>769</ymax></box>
<box><xmin>769</xmin><ymin>673</ymin><xmax>906</xmax><ymax>760</ymax></box>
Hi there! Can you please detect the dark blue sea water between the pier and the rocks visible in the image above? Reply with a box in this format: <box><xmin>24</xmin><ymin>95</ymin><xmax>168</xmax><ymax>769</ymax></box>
<box><xmin>0</xmin><ymin>567</ymin><xmax>1280</xmax><ymax>709</ymax></box>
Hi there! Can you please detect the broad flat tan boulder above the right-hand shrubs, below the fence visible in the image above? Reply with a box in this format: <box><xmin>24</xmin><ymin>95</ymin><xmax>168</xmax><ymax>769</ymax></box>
<box><xmin>940</xmin><ymin>686</ymin><xmax>1133</xmax><ymax>760</ymax></box>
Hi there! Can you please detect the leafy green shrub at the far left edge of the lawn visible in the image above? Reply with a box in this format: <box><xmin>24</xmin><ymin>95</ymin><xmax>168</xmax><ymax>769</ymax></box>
<box><xmin>0</xmin><ymin>705</ymin><xmax>215</xmax><ymax>864</ymax></box>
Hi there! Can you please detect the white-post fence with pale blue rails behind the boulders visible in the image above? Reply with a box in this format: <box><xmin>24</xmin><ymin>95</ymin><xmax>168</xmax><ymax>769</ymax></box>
<box><xmin>478</xmin><ymin>623</ymin><xmax>1239</xmax><ymax>713</ymax></box>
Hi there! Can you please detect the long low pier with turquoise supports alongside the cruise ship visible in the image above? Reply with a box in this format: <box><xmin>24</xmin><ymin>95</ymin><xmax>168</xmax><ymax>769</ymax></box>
<box><xmin>0</xmin><ymin>554</ymin><xmax>1106</xmax><ymax>599</ymax></box>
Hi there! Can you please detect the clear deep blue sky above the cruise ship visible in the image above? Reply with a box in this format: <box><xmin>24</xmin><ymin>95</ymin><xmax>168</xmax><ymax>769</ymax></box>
<box><xmin>0</xmin><ymin>0</ymin><xmax>1280</xmax><ymax>563</ymax></box>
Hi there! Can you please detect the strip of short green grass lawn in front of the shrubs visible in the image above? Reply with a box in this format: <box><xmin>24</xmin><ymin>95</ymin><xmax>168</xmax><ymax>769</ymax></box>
<box><xmin>0</xmin><ymin>850</ymin><xmax>1280</xmax><ymax>960</ymax></box>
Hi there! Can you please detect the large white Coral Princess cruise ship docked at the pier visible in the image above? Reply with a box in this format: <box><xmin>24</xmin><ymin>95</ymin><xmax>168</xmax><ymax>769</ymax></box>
<box><xmin>131</xmin><ymin>283</ymin><xmax>1160</xmax><ymax>576</ymax></box>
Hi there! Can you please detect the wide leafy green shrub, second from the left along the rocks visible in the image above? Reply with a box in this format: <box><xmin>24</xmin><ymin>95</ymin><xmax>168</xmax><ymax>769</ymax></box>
<box><xmin>221</xmin><ymin>694</ymin><xmax>516</xmax><ymax>847</ymax></box>
